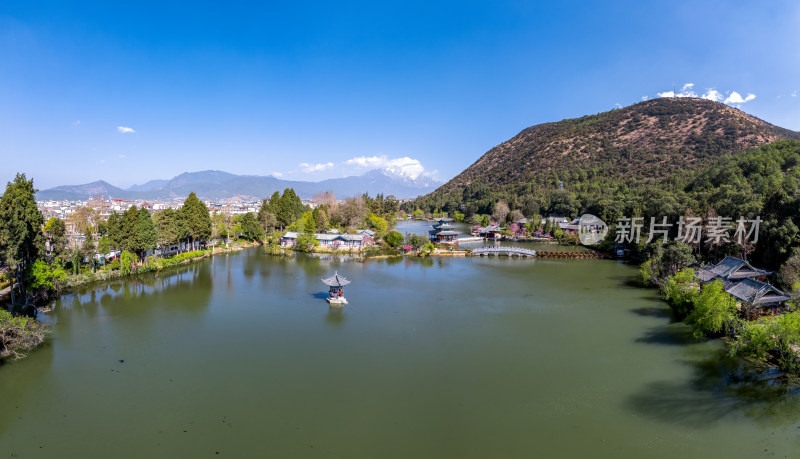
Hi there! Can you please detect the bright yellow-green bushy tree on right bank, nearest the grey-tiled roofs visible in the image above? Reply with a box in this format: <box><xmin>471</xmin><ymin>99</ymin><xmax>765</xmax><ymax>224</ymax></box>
<box><xmin>686</xmin><ymin>280</ymin><xmax>736</xmax><ymax>337</ymax></box>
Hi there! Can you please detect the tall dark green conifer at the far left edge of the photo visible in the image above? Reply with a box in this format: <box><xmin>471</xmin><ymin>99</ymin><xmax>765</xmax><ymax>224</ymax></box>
<box><xmin>0</xmin><ymin>174</ymin><xmax>45</xmax><ymax>306</ymax></box>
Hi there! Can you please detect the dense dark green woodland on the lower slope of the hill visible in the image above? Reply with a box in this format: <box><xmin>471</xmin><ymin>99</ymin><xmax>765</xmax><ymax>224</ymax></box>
<box><xmin>410</xmin><ymin>140</ymin><xmax>800</xmax><ymax>269</ymax></box>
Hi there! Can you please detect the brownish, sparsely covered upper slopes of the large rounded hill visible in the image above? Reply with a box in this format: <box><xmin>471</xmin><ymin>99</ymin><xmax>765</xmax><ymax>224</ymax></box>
<box><xmin>438</xmin><ymin>98</ymin><xmax>800</xmax><ymax>194</ymax></box>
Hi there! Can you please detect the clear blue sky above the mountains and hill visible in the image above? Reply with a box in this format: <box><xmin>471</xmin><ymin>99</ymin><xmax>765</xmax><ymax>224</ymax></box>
<box><xmin>0</xmin><ymin>0</ymin><xmax>800</xmax><ymax>189</ymax></box>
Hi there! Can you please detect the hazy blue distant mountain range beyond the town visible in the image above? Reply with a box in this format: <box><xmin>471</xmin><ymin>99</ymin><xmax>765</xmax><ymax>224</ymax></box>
<box><xmin>36</xmin><ymin>169</ymin><xmax>441</xmax><ymax>201</ymax></box>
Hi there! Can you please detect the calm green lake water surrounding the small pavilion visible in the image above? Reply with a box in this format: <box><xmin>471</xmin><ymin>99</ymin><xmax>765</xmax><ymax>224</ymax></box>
<box><xmin>0</xmin><ymin>232</ymin><xmax>800</xmax><ymax>458</ymax></box>
